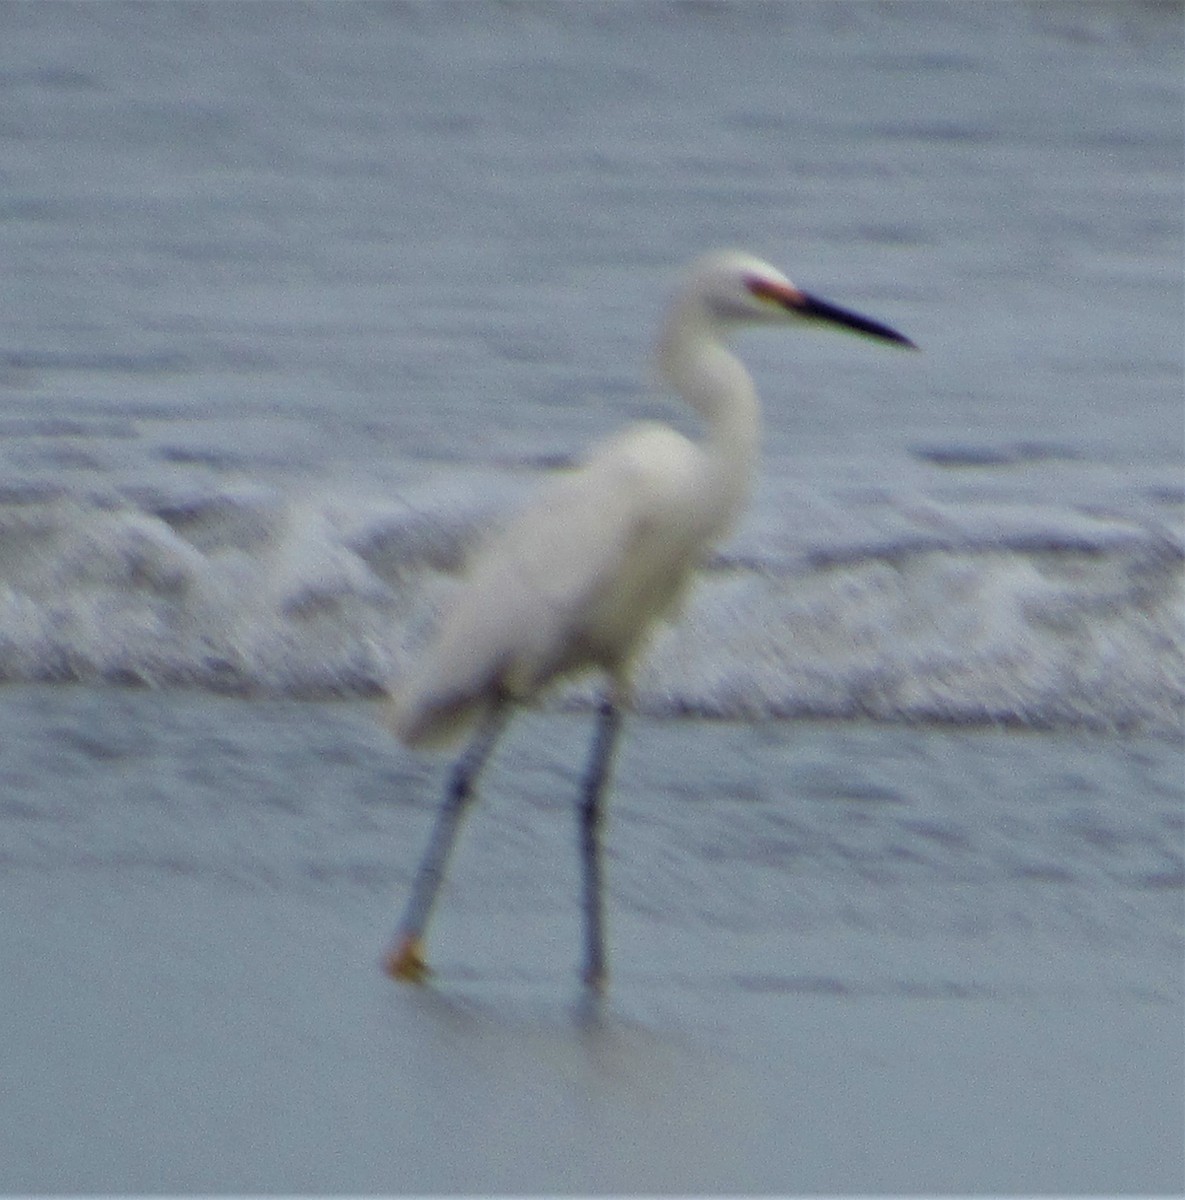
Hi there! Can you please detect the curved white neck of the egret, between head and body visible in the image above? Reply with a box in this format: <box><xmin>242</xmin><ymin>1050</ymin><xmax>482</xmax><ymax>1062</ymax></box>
<box><xmin>658</xmin><ymin>298</ymin><xmax>762</xmax><ymax>505</ymax></box>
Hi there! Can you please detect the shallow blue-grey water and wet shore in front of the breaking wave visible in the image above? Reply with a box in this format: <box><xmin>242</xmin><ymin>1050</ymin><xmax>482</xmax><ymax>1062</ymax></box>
<box><xmin>0</xmin><ymin>688</ymin><xmax>1185</xmax><ymax>1193</ymax></box>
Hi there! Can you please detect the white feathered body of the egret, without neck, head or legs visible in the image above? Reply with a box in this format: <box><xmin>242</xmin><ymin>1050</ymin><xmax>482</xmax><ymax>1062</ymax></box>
<box><xmin>393</xmin><ymin>424</ymin><xmax>740</xmax><ymax>745</ymax></box>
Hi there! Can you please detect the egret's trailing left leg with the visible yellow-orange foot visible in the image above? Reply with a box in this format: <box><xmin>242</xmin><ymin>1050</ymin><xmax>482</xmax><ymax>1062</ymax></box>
<box><xmin>386</xmin><ymin>700</ymin><xmax>509</xmax><ymax>983</ymax></box>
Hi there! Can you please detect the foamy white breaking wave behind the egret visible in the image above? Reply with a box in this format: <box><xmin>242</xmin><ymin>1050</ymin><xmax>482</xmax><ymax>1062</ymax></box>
<box><xmin>0</xmin><ymin>490</ymin><xmax>1185</xmax><ymax>731</ymax></box>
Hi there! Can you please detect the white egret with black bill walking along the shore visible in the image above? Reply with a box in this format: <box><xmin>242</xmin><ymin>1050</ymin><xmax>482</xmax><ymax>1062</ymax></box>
<box><xmin>385</xmin><ymin>251</ymin><xmax>916</xmax><ymax>992</ymax></box>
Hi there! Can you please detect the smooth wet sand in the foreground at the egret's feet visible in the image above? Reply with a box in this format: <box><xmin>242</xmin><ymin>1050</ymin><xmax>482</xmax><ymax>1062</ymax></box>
<box><xmin>0</xmin><ymin>854</ymin><xmax>1183</xmax><ymax>1193</ymax></box>
